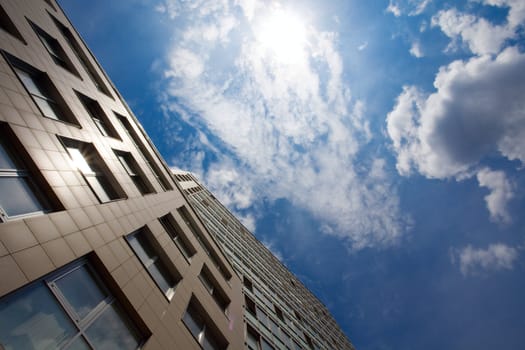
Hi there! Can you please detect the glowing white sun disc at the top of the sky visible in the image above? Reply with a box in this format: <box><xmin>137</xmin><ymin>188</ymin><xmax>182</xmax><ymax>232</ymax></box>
<box><xmin>255</xmin><ymin>7</ymin><xmax>307</xmax><ymax>64</ymax></box>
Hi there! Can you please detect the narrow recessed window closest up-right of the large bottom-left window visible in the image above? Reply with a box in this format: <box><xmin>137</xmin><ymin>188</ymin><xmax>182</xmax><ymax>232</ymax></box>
<box><xmin>126</xmin><ymin>227</ymin><xmax>181</xmax><ymax>300</ymax></box>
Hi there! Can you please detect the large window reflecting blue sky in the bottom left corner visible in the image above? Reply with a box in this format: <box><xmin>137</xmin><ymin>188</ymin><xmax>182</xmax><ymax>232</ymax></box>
<box><xmin>0</xmin><ymin>260</ymin><xmax>146</xmax><ymax>349</ymax></box>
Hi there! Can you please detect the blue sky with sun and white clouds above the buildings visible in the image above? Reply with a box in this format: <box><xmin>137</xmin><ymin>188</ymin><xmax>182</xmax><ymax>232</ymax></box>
<box><xmin>60</xmin><ymin>0</ymin><xmax>525</xmax><ymax>349</ymax></box>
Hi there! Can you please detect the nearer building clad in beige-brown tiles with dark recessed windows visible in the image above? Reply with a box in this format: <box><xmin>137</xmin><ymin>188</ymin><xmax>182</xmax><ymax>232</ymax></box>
<box><xmin>0</xmin><ymin>0</ymin><xmax>352</xmax><ymax>350</ymax></box>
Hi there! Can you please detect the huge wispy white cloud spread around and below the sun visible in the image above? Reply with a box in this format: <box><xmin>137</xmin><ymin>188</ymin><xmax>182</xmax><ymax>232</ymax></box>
<box><xmin>155</xmin><ymin>0</ymin><xmax>407</xmax><ymax>249</ymax></box>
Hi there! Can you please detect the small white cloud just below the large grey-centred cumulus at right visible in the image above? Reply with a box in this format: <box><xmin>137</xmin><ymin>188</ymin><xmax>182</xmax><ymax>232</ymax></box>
<box><xmin>477</xmin><ymin>168</ymin><xmax>514</xmax><ymax>223</ymax></box>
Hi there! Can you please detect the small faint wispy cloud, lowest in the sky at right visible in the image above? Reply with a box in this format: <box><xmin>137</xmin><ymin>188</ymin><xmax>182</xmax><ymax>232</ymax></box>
<box><xmin>452</xmin><ymin>243</ymin><xmax>518</xmax><ymax>275</ymax></box>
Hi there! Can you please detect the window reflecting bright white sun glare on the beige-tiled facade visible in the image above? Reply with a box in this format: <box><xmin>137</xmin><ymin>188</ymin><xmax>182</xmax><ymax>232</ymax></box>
<box><xmin>61</xmin><ymin>139</ymin><xmax>121</xmax><ymax>202</ymax></box>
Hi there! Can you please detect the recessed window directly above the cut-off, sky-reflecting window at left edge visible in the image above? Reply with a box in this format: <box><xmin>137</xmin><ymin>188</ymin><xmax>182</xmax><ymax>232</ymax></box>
<box><xmin>3</xmin><ymin>52</ymin><xmax>78</xmax><ymax>125</ymax></box>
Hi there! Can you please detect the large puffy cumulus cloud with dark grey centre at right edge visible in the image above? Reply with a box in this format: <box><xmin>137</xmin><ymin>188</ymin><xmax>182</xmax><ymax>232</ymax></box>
<box><xmin>387</xmin><ymin>47</ymin><xmax>525</xmax><ymax>178</ymax></box>
